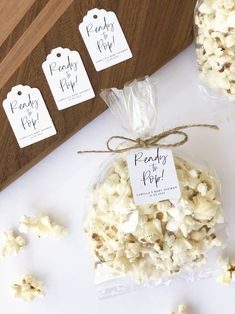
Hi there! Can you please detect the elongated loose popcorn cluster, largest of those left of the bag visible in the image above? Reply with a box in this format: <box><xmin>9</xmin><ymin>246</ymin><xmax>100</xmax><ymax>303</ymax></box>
<box><xmin>19</xmin><ymin>216</ymin><xmax>67</xmax><ymax>239</ymax></box>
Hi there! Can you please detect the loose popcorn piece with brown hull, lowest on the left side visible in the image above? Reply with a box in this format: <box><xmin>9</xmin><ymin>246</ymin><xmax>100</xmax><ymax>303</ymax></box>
<box><xmin>11</xmin><ymin>275</ymin><xmax>45</xmax><ymax>301</ymax></box>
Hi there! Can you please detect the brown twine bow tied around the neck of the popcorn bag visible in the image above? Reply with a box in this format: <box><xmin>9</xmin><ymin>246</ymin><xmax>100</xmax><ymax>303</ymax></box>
<box><xmin>78</xmin><ymin>124</ymin><xmax>219</xmax><ymax>154</ymax></box>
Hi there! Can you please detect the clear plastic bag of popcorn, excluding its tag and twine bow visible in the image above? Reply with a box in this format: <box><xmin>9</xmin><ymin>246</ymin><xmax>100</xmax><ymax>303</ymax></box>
<box><xmin>85</xmin><ymin>78</ymin><xmax>224</xmax><ymax>298</ymax></box>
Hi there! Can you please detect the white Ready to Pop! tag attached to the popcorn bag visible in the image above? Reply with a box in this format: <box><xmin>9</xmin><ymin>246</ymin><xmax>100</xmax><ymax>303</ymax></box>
<box><xmin>127</xmin><ymin>148</ymin><xmax>181</xmax><ymax>205</ymax></box>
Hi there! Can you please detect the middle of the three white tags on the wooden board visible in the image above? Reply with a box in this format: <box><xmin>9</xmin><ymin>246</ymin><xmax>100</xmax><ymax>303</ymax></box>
<box><xmin>42</xmin><ymin>47</ymin><xmax>95</xmax><ymax>110</ymax></box>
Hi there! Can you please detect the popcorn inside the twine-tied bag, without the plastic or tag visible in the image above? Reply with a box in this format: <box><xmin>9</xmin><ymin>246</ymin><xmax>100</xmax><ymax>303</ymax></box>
<box><xmin>85</xmin><ymin>157</ymin><xmax>224</xmax><ymax>282</ymax></box>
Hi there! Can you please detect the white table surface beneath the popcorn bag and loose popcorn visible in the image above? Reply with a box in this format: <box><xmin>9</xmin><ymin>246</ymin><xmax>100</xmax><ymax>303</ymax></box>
<box><xmin>0</xmin><ymin>46</ymin><xmax>235</xmax><ymax>314</ymax></box>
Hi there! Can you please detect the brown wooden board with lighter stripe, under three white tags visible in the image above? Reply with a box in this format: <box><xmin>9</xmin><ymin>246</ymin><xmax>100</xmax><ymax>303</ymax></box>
<box><xmin>0</xmin><ymin>0</ymin><xmax>196</xmax><ymax>189</ymax></box>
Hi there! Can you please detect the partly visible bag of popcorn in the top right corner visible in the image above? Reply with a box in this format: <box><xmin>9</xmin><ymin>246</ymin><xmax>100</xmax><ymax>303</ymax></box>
<box><xmin>195</xmin><ymin>0</ymin><xmax>235</xmax><ymax>101</ymax></box>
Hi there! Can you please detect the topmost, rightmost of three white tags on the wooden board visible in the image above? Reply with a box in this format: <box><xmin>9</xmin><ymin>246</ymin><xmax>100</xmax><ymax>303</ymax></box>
<box><xmin>79</xmin><ymin>9</ymin><xmax>132</xmax><ymax>71</ymax></box>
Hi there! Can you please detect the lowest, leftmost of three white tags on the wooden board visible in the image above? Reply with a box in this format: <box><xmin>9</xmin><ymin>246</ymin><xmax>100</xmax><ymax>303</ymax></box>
<box><xmin>3</xmin><ymin>85</ymin><xmax>56</xmax><ymax>148</ymax></box>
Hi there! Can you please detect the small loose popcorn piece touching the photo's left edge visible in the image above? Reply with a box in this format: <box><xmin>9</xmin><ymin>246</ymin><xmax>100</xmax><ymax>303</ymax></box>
<box><xmin>2</xmin><ymin>230</ymin><xmax>26</xmax><ymax>257</ymax></box>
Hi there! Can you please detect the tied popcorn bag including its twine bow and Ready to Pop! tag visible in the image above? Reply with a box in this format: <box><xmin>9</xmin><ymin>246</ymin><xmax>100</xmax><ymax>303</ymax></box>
<box><xmin>82</xmin><ymin>77</ymin><xmax>224</xmax><ymax>298</ymax></box>
